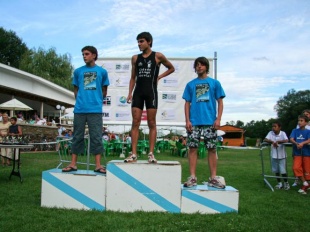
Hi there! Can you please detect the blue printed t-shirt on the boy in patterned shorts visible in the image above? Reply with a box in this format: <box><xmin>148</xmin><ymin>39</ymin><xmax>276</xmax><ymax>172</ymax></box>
<box><xmin>182</xmin><ymin>77</ymin><xmax>226</xmax><ymax>126</ymax></box>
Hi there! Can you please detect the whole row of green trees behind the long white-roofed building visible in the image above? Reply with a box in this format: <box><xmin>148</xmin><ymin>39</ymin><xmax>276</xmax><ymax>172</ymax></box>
<box><xmin>0</xmin><ymin>27</ymin><xmax>74</xmax><ymax>91</ymax></box>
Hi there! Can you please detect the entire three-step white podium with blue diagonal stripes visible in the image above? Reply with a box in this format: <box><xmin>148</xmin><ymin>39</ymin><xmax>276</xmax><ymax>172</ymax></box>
<box><xmin>41</xmin><ymin>160</ymin><xmax>239</xmax><ymax>214</ymax></box>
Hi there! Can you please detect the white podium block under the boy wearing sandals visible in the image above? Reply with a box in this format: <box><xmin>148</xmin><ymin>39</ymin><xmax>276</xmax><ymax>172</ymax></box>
<box><xmin>41</xmin><ymin>169</ymin><xmax>106</xmax><ymax>211</ymax></box>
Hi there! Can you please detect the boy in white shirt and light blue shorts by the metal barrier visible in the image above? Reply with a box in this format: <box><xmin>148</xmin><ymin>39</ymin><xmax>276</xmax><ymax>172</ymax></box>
<box><xmin>264</xmin><ymin>122</ymin><xmax>290</xmax><ymax>190</ymax></box>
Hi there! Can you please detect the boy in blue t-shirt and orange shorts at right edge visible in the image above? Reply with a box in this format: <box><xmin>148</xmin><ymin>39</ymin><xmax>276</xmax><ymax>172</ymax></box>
<box><xmin>290</xmin><ymin>115</ymin><xmax>310</xmax><ymax>194</ymax></box>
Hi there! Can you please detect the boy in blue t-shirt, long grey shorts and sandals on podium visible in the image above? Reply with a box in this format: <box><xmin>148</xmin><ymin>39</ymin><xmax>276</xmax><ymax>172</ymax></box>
<box><xmin>62</xmin><ymin>46</ymin><xmax>110</xmax><ymax>174</ymax></box>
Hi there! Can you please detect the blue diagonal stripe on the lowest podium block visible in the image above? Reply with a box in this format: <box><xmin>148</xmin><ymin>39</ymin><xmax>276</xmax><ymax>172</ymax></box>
<box><xmin>182</xmin><ymin>190</ymin><xmax>237</xmax><ymax>213</ymax></box>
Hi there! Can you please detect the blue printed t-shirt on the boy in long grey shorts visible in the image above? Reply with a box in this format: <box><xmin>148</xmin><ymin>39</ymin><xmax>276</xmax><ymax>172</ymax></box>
<box><xmin>72</xmin><ymin>65</ymin><xmax>110</xmax><ymax>114</ymax></box>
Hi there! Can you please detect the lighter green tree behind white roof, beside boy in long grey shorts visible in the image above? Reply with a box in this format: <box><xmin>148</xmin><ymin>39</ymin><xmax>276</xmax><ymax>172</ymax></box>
<box><xmin>19</xmin><ymin>47</ymin><xmax>73</xmax><ymax>90</ymax></box>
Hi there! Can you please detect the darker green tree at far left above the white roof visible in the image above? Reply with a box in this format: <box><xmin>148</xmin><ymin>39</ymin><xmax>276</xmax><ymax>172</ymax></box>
<box><xmin>0</xmin><ymin>27</ymin><xmax>28</xmax><ymax>68</ymax></box>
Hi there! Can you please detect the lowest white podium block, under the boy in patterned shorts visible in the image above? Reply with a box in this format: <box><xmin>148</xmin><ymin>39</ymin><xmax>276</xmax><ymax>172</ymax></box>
<box><xmin>181</xmin><ymin>185</ymin><xmax>239</xmax><ymax>214</ymax></box>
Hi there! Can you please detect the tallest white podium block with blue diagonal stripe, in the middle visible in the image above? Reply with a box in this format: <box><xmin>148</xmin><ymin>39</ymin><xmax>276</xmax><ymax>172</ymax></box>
<box><xmin>106</xmin><ymin>160</ymin><xmax>181</xmax><ymax>213</ymax></box>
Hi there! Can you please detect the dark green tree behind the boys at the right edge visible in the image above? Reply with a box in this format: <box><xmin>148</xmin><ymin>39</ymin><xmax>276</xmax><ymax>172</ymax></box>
<box><xmin>275</xmin><ymin>89</ymin><xmax>310</xmax><ymax>136</ymax></box>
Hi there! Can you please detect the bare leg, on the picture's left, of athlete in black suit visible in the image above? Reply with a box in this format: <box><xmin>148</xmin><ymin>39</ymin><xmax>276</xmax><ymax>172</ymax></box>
<box><xmin>131</xmin><ymin>107</ymin><xmax>142</xmax><ymax>154</ymax></box>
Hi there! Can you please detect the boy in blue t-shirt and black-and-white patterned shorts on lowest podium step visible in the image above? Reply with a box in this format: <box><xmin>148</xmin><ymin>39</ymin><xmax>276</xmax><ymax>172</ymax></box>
<box><xmin>183</xmin><ymin>57</ymin><xmax>225</xmax><ymax>188</ymax></box>
